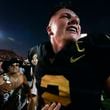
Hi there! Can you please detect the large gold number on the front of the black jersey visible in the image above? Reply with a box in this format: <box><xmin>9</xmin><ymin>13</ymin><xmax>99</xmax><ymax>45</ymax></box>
<box><xmin>41</xmin><ymin>75</ymin><xmax>71</xmax><ymax>106</ymax></box>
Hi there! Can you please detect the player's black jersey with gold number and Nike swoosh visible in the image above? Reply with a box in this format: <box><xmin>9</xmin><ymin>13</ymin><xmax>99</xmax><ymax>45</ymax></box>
<box><xmin>33</xmin><ymin>35</ymin><xmax>110</xmax><ymax>110</ymax></box>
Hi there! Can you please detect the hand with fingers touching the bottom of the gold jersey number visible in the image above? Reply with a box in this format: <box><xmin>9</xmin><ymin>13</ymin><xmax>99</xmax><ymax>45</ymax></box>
<box><xmin>41</xmin><ymin>102</ymin><xmax>61</xmax><ymax>110</ymax></box>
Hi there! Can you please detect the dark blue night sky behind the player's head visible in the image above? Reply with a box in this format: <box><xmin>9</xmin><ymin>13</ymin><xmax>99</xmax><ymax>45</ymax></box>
<box><xmin>0</xmin><ymin>0</ymin><xmax>110</xmax><ymax>56</ymax></box>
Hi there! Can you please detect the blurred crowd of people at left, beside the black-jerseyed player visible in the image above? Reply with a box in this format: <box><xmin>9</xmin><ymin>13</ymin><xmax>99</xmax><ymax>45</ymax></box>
<box><xmin>0</xmin><ymin>50</ymin><xmax>37</xmax><ymax>110</ymax></box>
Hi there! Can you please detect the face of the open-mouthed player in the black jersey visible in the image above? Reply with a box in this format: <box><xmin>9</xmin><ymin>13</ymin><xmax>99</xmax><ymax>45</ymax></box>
<box><xmin>48</xmin><ymin>8</ymin><xmax>81</xmax><ymax>41</ymax></box>
